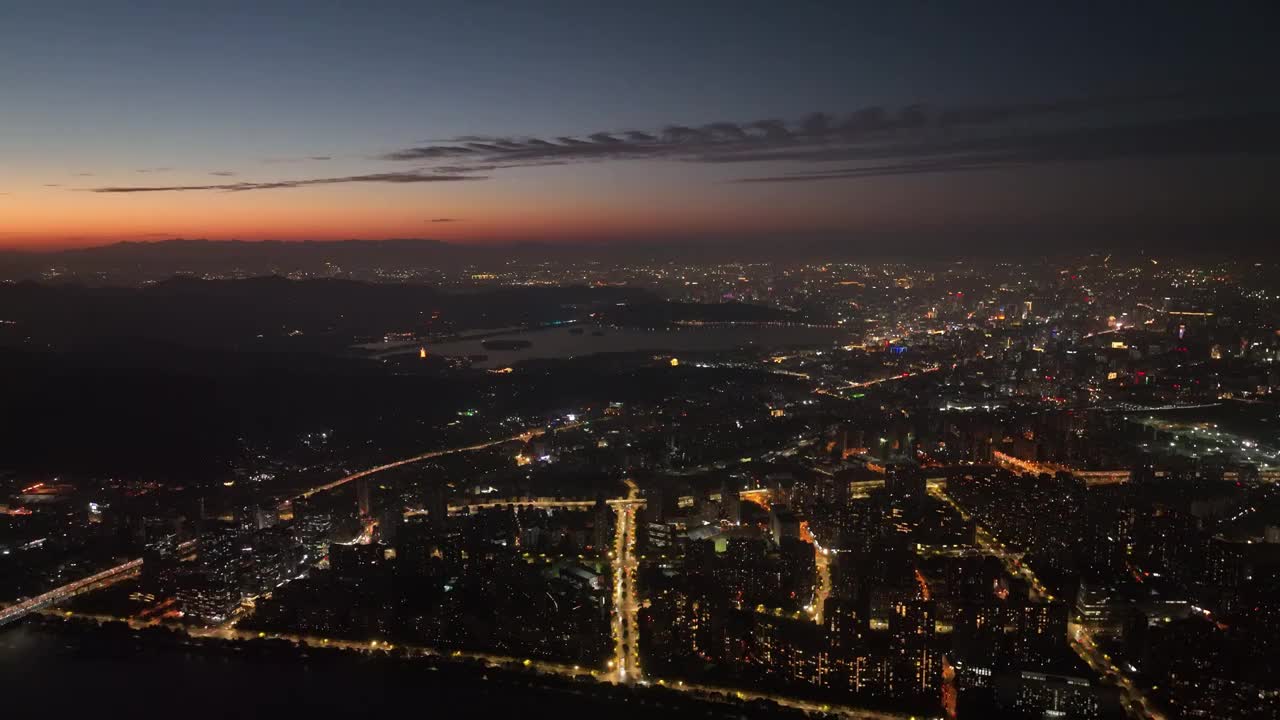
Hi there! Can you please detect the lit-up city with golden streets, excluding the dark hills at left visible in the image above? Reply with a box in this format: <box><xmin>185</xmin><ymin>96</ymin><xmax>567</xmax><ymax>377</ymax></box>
<box><xmin>0</xmin><ymin>249</ymin><xmax>1280</xmax><ymax>717</ymax></box>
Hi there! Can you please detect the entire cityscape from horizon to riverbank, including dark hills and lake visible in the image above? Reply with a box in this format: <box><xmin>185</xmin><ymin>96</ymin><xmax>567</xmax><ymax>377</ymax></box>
<box><xmin>0</xmin><ymin>243</ymin><xmax>1280</xmax><ymax>720</ymax></box>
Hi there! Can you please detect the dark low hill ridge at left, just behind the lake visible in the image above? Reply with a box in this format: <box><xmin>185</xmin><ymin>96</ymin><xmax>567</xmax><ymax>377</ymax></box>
<box><xmin>0</xmin><ymin>277</ymin><xmax>658</xmax><ymax>351</ymax></box>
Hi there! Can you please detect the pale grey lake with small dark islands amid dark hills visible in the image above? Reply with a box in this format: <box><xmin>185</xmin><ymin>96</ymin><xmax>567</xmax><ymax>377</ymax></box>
<box><xmin>428</xmin><ymin>325</ymin><xmax>849</xmax><ymax>368</ymax></box>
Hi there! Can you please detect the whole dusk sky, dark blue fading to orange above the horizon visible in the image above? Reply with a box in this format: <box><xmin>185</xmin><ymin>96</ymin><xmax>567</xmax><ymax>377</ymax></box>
<box><xmin>0</xmin><ymin>0</ymin><xmax>1280</xmax><ymax>249</ymax></box>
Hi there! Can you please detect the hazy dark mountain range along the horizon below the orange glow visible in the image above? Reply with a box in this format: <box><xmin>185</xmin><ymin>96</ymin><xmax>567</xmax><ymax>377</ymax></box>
<box><xmin>0</xmin><ymin>225</ymin><xmax>1276</xmax><ymax>284</ymax></box>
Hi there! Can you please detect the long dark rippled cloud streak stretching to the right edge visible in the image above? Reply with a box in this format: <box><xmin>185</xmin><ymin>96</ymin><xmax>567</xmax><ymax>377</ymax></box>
<box><xmin>383</xmin><ymin>95</ymin><xmax>1280</xmax><ymax>182</ymax></box>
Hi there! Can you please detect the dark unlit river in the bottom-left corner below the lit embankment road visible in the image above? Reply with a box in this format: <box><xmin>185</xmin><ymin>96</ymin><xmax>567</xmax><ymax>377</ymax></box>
<box><xmin>0</xmin><ymin>620</ymin><xmax>797</xmax><ymax>720</ymax></box>
